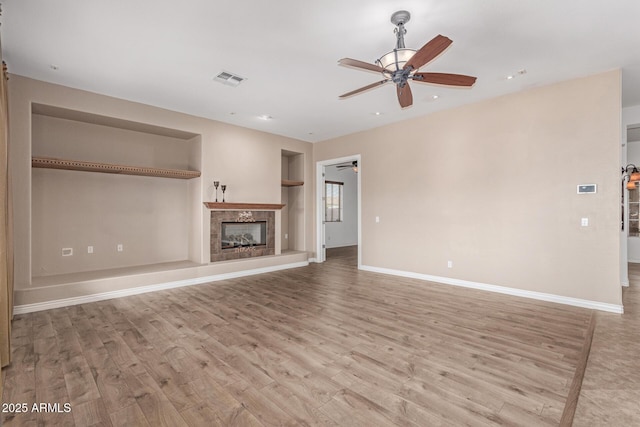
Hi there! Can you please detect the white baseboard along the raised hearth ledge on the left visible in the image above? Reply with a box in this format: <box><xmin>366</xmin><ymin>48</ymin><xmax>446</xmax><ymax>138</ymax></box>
<box><xmin>13</xmin><ymin>261</ymin><xmax>309</xmax><ymax>314</ymax></box>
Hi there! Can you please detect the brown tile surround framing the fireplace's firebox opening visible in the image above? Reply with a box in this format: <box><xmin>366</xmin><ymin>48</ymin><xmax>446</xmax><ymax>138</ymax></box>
<box><xmin>211</xmin><ymin>210</ymin><xmax>276</xmax><ymax>262</ymax></box>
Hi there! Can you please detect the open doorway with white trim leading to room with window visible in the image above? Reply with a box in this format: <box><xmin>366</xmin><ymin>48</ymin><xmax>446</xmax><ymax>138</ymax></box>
<box><xmin>316</xmin><ymin>154</ymin><xmax>362</xmax><ymax>268</ymax></box>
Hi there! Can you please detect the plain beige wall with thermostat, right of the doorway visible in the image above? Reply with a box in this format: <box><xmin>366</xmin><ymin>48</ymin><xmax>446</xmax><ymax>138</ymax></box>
<box><xmin>314</xmin><ymin>71</ymin><xmax>621</xmax><ymax>305</ymax></box>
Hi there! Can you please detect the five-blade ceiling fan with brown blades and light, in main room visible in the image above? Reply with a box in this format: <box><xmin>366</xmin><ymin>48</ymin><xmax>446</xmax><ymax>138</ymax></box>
<box><xmin>338</xmin><ymin>10</ymin><xmax>476</xmax><ymax>108</ymax></box>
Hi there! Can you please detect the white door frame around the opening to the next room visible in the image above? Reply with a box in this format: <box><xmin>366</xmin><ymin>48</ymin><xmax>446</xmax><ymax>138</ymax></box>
<box><xmin>315</xmin><ymin>154</ymin><xmax>362</xmax><ymax>269</ymax></box>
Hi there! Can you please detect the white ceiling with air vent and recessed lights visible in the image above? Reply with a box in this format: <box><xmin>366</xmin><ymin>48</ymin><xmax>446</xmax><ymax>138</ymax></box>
<box><xmin>0</xmin><ymin>0</ymin><xmax>640</xmax><ymax>142</ymax></box>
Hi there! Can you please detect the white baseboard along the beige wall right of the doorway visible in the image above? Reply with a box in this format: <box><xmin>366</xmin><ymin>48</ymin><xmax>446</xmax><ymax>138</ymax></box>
<box><xmin>360</xmin><ymin>265</ymin><xmax>624</xmax><ymax>314</ymax></box>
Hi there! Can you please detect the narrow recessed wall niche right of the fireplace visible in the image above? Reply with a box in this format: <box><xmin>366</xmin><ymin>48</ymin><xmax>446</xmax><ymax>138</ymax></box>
<box><xmin>280</xmin><ymin>150</ymin><xmax>304</xmax><ymax>252</ymax></box>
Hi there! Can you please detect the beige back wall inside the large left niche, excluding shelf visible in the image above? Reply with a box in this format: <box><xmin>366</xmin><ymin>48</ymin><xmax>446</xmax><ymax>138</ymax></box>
<box><xmin>31</xmin><ymin>114</ymin><xmax>200</xmax><ymax>277</ymax></box>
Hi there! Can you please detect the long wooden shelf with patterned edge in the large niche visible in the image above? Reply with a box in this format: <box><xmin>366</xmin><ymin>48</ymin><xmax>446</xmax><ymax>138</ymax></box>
<box><xmin>31</xmin><ymin>157</ymin><xmax>200</xmax><ymax>179</ymax></box>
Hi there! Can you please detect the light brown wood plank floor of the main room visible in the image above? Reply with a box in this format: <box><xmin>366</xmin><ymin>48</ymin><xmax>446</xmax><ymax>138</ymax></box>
<box><xmin>2</xmin><ymin>248</ymin><xmax>591</xmax><ymax>426</ymax></box>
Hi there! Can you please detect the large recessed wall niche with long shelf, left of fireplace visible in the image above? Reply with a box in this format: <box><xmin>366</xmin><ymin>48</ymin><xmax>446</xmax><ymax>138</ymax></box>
<box><xmin>31</xmin><ymin>104</ymin><xmax>202</xmax><ymax>283</ymax></box>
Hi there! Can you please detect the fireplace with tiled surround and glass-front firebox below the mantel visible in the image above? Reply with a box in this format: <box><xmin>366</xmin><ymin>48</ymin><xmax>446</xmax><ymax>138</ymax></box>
<box><xmin>211</xmin><ymin>210</ymin><xmax>276</xmax><ymax>262</ymax></box>
